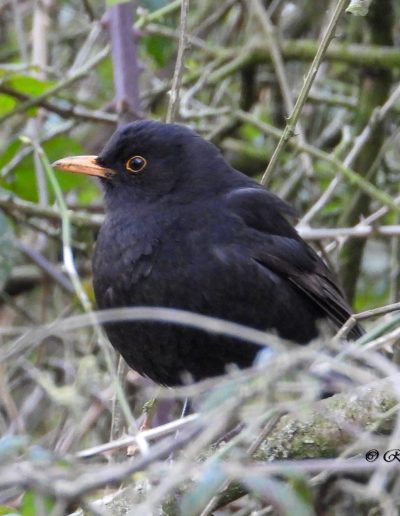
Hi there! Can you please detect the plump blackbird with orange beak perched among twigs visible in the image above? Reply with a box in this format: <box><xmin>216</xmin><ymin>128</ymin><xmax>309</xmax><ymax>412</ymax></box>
<box><xmin>54</xmin><ymin>121</ymin><xmax>363</xmax><ymax>386</ymax></box>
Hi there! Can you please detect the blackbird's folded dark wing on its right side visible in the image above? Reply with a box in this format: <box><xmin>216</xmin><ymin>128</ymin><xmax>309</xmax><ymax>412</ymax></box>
<box><xmin>224</xmin><ymin>187</ymin><xmax>363</xmax><ymax>338</ymax></box>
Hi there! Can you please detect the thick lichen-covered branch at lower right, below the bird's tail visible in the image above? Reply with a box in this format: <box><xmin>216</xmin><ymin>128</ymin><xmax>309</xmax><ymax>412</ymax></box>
<box><xmin>254</xmin><ymin>375</ymin><xmax>400</xmax><ymax>461</ymax></box>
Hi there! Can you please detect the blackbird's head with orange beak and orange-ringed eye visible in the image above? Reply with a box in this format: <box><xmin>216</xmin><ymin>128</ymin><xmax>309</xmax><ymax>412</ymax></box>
<box><xmin>54</xmin><ymin>120</ymin><xmax>231</xmax><ymax>206</ymax></box>
